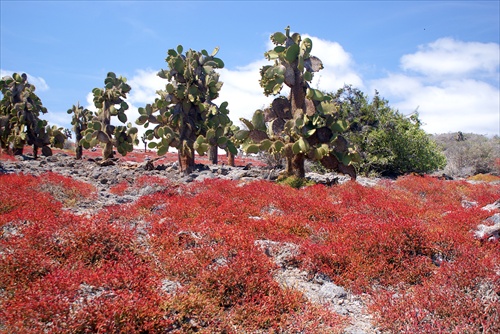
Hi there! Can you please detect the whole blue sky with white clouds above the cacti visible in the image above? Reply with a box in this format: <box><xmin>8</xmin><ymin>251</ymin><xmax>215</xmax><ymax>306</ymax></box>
<box><xmin>0</xmin><ymin>0</ymin><xmax>500</xmax><ymax>135</ymax></box>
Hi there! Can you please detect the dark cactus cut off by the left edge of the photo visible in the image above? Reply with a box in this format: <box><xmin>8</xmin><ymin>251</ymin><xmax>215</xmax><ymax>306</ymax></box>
<box><xmin>0</xmin><ymin>73</ymin><xmax>66</xmax><ymax>159</ymax></box>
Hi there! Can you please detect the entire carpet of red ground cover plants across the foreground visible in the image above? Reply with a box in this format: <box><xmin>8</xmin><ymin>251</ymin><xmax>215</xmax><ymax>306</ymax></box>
<box><xmin>0</xmin><ymin>171</ymin><xmax>500</xmax><ymax>333</ymax></box>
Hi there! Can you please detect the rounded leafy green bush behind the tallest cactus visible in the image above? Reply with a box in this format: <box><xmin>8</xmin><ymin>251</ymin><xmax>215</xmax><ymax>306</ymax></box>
<box><xmin>334</xmin><ymin>86</ymin><xmax>446</xmax><ymax>175</ymax></box>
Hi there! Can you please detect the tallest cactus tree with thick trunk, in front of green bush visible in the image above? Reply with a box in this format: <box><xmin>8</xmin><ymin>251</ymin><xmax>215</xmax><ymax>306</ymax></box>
<box><xmin>235</xmin><ymin>27</ymin><xmax>357</xmax><ymax>179</ymax></box>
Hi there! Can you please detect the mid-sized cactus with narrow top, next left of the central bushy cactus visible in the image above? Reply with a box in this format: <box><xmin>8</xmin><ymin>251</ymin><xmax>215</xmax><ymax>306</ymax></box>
<box><xmin>79</xmin><ymin>72</ymin><xmax>139</xmax><ymax>160</ymax></box>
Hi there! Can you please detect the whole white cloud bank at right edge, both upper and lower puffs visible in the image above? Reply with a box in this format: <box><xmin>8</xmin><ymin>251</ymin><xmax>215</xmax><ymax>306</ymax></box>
<box><xmin>370</xmin><ymin>38</ymin><xmax>500</xmax><ymax>135</ymax></box>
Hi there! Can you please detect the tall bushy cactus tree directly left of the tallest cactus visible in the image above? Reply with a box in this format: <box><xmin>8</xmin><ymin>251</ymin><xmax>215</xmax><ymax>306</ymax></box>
<box><xmin>136</xmin><ymin>45</ymin><xmax>236</xmax><ymax>174</ymax></box>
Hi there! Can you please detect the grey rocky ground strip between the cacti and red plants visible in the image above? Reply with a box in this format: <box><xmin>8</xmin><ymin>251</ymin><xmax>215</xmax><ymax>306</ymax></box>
<box><xmin>0</xmin><ymin>153</ymin><xmax>378</xmax><ymax>212</ymax></box>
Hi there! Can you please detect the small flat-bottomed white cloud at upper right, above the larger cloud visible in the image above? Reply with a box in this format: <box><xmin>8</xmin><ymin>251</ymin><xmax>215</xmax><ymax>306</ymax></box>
<box><xmin>401</xmin><ymin>38</ymin><xmax>500</xmax><ymax>79</ymax></box>
